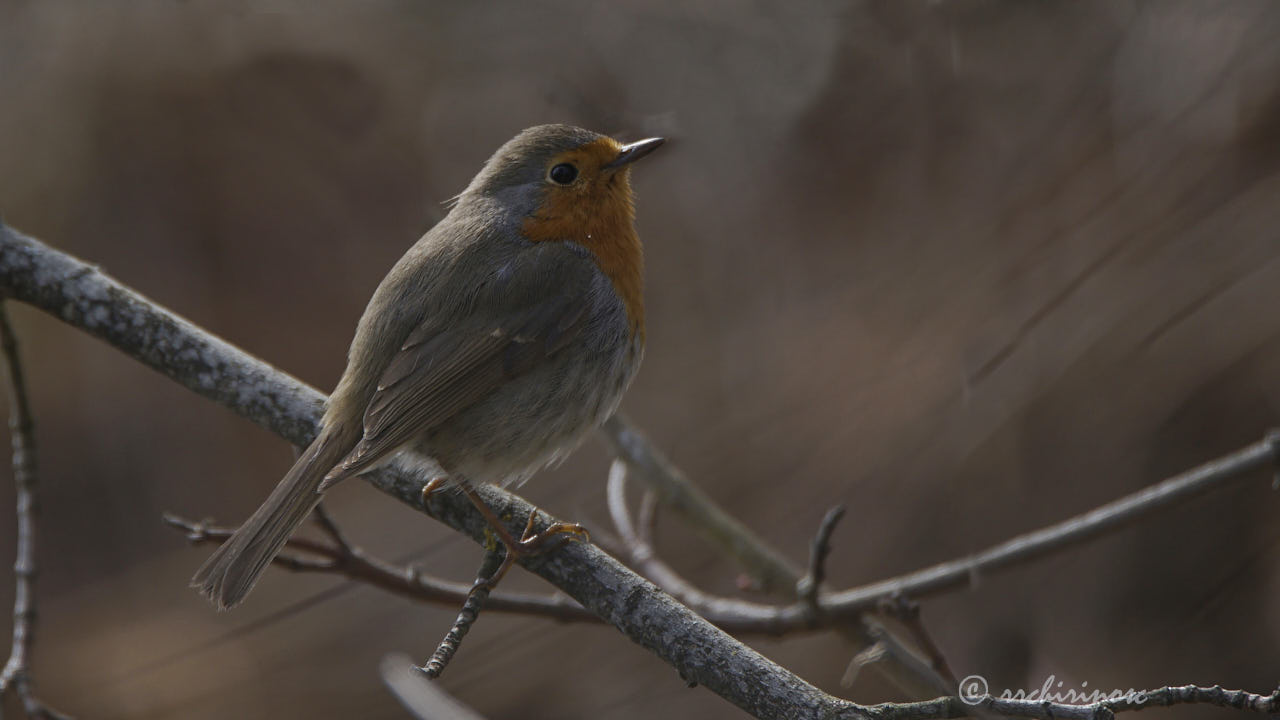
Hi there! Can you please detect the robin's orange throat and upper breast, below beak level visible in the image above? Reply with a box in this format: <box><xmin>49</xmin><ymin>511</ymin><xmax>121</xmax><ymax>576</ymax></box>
<box><xmin>521</xmin><ymin>174</ymin><xmax>644</xmax><ymax>340</ymax></box>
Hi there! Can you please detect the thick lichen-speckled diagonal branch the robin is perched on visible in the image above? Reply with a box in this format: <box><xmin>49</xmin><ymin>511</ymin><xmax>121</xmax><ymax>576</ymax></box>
<box><xmin>0</xmin><ymin>225</ymin><xmax>863</xmax><ymax>719</ymax></box>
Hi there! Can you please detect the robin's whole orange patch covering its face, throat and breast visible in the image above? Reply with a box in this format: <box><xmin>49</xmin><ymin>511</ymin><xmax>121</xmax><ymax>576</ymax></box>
<box><xmin>521</xmin><ymin>137</ymin><xmax>644</xmax><ymax>336</ymax></box>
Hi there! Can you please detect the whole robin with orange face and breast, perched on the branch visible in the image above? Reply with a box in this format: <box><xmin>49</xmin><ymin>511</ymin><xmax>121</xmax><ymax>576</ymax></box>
<box><xmin>191</xmin><ymin>126</ymin><xmax>663</xmax><ymax>609</ymax></box>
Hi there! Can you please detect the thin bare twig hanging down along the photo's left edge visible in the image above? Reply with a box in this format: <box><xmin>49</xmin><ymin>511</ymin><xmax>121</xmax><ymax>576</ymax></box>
<box><xmin>0</xmin><ymin>304</ymin><xmax>65</xmax><ymax>719</ymax></box>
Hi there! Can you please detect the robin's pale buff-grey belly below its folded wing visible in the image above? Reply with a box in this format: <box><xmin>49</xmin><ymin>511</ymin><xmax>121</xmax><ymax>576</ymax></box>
<box><xmin>416</xmin><ymin>330</ymin><xmax>643</xmax><ymax>484</ymax></box>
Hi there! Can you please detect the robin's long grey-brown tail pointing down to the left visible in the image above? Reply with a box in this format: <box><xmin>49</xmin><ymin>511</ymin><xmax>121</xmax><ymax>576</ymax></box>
<box><xmin>191</xmin><ymin>425</ymin><xmax>357</xmax><ymax>610</ymax></box>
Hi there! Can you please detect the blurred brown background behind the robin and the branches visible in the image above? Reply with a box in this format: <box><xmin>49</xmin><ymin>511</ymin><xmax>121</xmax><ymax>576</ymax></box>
<box><xmin>0</xmin><ymin>0</ymin><xmax>1280</xmax><ymax>719</ymax></box>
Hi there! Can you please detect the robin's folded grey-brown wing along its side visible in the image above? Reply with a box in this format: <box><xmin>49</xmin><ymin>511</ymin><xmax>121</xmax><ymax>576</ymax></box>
<box><xmin>325</xmin><ymin>243</ymin><xmax>599</xmax><ymax>487</ymax></box>
